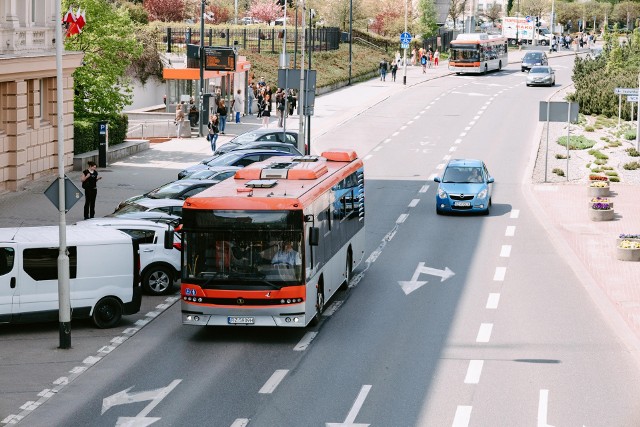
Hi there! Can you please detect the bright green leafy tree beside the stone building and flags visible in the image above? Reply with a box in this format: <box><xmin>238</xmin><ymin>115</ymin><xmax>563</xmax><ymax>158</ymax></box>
<box><xmin>62</xmin><ymin>0</ymin><xmax>142</xmax><ymax>117</ymax></box>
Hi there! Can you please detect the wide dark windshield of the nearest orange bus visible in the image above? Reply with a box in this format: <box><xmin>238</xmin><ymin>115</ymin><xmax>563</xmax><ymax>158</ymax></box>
<box><xmin>182</xmin><ymin>211</ymin><xmax>304</xmax><ymax>289</ymax></box>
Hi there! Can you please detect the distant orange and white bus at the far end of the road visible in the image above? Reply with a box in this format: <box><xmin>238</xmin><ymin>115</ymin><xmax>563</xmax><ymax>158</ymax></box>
<box><xmin>449</xmin><ymin>33</ymin><xmax>509</xmax><ymax>74</ymax></box>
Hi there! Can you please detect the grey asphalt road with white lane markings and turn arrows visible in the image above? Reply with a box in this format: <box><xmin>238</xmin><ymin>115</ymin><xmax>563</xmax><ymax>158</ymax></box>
<box><xmin>11</xmin><ymin>54</ymin><xmax>640</xmax><ymax>427</ymax></box>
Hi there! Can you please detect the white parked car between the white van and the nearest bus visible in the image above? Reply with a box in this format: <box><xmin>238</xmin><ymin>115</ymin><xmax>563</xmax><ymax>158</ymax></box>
<box><xmin>78</xmin><ymin>217</ymin><xmax>180</xmax><ymax>295</ymax></box>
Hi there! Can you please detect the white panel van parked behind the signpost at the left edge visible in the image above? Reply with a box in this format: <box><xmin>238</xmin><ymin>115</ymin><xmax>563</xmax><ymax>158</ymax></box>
<box><xmin>0</xmin><ymin>225</ymin><xmax>142</xmax><ymax>328</ymax></box>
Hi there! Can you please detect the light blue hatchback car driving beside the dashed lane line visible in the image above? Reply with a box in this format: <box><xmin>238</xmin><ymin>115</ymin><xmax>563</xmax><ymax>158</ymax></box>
<box><xmin>433</xmin><ymin>159</ymin><xmax>493</xmax><ymax>215</ymax></box>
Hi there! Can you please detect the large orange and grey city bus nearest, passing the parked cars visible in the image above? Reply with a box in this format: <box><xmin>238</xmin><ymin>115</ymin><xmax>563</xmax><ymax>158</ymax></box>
<box><xmin>181</xmin><ymin>149</ymin><xmax>365</xmax><ymax>327</ymax></box>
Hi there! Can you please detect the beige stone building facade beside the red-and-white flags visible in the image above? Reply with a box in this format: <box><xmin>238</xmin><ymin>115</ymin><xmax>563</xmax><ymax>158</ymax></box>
<box><xmin>0</xmin><ymin>0</ymin><xmax>83</xmax><ymax>191</ymax></box>
